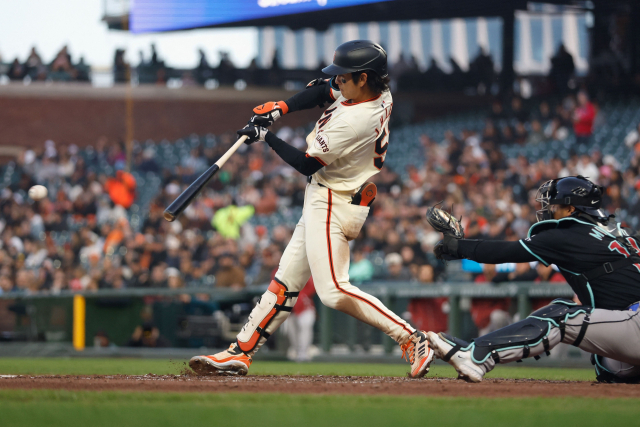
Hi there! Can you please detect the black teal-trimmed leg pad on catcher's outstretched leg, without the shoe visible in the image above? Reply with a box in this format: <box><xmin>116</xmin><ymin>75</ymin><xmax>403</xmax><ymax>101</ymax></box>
<box><xmin>472</xmin><ymin>299</ymin><xmax>591</xmax><ymax>363</ymax></box>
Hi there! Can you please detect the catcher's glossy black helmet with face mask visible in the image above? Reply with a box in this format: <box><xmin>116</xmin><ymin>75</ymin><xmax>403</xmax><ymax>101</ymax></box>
<box><xmin>536</xmin><ymin>175</ymin><xmax>608</xmax><ymax>221</ymax></box>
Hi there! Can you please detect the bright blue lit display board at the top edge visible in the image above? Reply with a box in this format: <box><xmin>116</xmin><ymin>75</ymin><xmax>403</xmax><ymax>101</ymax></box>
<box><xmin>130</xmin><ymin>0</ymin><xmax>391</xmax><ymax>33</ymax></box>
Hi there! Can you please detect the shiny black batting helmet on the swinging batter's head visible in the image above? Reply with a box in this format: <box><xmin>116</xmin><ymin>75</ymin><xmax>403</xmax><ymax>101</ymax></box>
<box><xmin>322</xmin><ymin>40</ymin><xmax>389</xmax><ymax>78</ymax></box>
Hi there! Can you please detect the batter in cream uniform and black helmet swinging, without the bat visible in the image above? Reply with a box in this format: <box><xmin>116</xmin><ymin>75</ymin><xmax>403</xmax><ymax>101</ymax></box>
<box><xmin>189</xmin><ymin>40</ymin><xmax>433</xmax><ymax>377</ymax></box>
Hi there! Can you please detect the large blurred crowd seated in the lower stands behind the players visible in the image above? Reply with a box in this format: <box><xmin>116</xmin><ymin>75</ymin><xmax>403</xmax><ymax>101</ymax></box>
<box><xmin>0</xmin><ymin>93</ymin><xmax>640</xmax><ymax>336</ymax></box>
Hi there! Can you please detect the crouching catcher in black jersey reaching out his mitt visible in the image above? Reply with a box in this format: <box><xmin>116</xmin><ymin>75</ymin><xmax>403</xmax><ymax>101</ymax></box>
<box><xmin>427</xmin><ymin>176</ymin><xmax>640</xmax><ymax>383</ymax></box>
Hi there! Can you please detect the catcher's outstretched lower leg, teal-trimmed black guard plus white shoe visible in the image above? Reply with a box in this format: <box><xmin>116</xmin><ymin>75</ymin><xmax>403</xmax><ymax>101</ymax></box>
<box><xmin>430</xmin><ymin>299</ymin><xmax>592</xmax><ymax>382</ymax></box>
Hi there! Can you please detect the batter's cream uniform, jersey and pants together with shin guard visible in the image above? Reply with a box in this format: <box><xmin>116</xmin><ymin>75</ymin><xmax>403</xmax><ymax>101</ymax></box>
<box><xmin>230</xmin><ymin>83</ymin><xmax>415</xmax><ymax>362</ymax></box>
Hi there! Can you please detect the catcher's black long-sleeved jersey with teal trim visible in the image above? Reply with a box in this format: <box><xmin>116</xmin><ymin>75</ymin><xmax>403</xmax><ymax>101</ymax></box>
<box><xmin>458</xmin><ymin>217</ymin><xmax>640</xmax><ymax>310</ymax></box>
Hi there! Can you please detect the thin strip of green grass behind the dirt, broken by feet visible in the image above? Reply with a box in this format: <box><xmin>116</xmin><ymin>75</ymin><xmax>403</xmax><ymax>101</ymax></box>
<box><xmin>0</xmin><ymin>358</ymin><xmax>595</xmax><ymax>381</ymax></box>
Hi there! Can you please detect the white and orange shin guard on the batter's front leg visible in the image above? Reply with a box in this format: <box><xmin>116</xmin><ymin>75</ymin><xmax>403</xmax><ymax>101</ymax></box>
<box><xmin>237</xmin><ymin>279</ymin><xmax>299</xmax><ymax>353</ymax></box>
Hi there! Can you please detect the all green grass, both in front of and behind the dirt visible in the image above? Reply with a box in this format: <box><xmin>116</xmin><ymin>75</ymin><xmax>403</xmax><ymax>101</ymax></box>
<box><xmin>0</xmin><ymin>358</ymin><xmax>640</xmax><ymax>427</ymax></box>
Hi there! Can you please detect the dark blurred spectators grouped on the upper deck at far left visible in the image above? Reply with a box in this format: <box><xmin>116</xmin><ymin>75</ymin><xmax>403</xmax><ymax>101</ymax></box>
<box><xmin>0</xmin><ymin>45</ymin><xmax>91</xmax><ymax>82</ymax></box>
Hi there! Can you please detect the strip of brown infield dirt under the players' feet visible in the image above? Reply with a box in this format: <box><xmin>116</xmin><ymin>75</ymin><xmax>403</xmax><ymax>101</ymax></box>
<box><xmin>0</xmin><ymin>374</ymin><xmax>640</xmax><ymax>398</ymax></box>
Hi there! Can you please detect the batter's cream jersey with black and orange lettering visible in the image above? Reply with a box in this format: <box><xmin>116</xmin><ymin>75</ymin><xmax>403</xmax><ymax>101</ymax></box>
<box><xmin>307</xmin><ymin>89</ymin><xmax>393</xmax><ymax>191</ymax></box>
